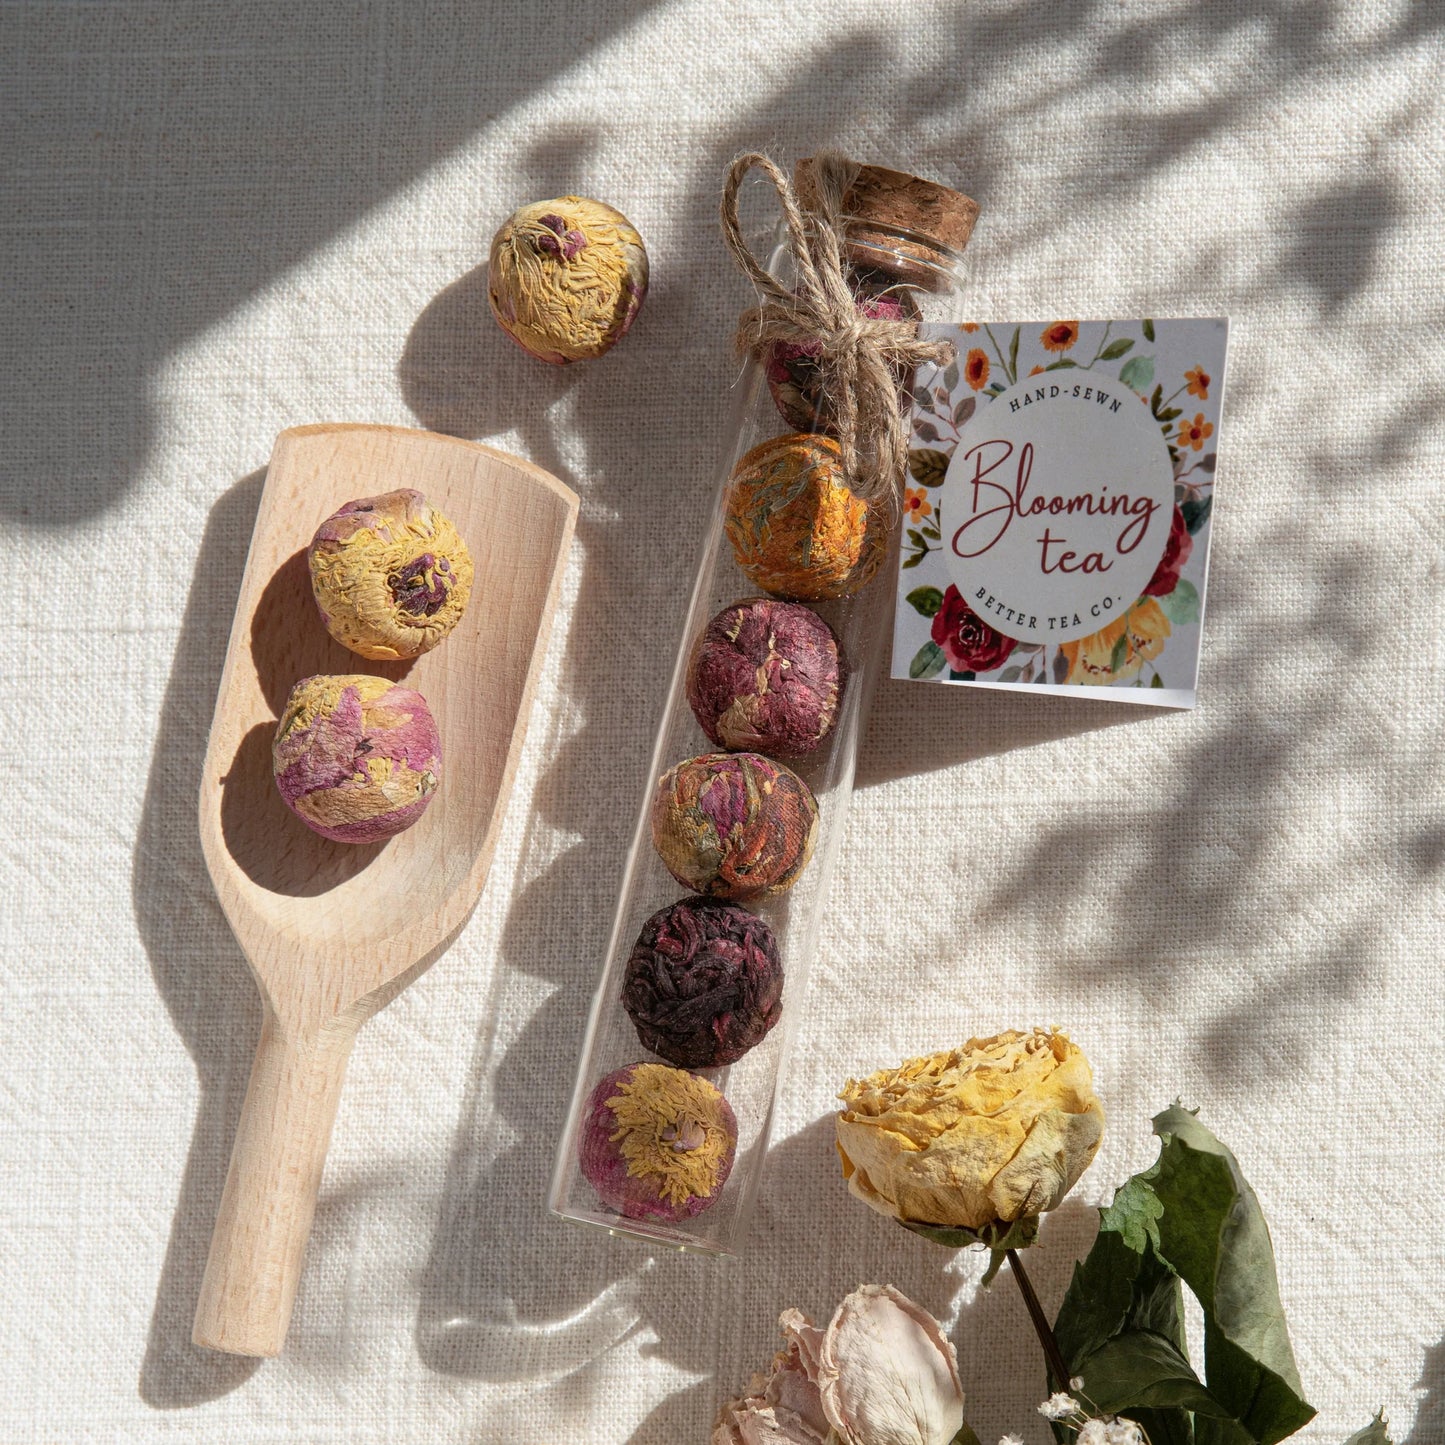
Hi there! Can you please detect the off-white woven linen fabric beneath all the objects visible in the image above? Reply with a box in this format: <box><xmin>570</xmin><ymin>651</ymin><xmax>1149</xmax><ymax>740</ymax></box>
<box><xmin>0</xmin><ymin>0</ymin><xmax>1445</xmax><ymax>1445</ymax></box>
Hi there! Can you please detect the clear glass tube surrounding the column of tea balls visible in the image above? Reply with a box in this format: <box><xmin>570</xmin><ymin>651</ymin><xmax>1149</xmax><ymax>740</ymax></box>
<box><xmin>548</xmin><ymin>217</ymin><xmax>961</xmax><ymax>1254</ymax></box>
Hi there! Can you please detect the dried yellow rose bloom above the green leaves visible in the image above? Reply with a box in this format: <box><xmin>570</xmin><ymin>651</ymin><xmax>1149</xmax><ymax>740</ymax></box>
<box><xmin>837</xmin><ymin>1029</ymin><xmax>1104</xmax><ymax>1231</ymax></box>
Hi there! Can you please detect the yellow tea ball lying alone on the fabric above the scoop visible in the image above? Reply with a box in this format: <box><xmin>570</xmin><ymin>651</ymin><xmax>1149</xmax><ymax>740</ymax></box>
<box><xmin>487</xmin><ymin>195</ymin><xmax>647</xmax><ymax>366</ymax></box>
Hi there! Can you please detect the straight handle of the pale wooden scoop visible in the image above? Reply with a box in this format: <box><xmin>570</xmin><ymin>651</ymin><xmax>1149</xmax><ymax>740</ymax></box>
<box><xmin>191</xmin><ymin>1007</ymin><xmax>360</xmax><ymax>1355</ymax></box>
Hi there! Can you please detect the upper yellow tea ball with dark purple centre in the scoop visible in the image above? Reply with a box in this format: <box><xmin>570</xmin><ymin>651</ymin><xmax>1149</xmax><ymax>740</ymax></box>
<box><xmin>306</xmin><ymin>487</ymin><xmax>471</xmax><ymax>660</ymax></box>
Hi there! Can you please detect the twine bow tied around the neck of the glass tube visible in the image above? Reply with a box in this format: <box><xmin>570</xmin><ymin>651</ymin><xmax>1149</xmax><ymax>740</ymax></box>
<box><xmin>723</xmin><ymin>150</ymin><xmax>954</xmax><ymax>506</ymax></box>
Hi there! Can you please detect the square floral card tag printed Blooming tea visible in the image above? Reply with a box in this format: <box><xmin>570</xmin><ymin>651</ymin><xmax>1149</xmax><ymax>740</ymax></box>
<box><xmin>893</xmin><ymin>319</ymin><xmax>1228</xmax><ymax>707</ymax></box>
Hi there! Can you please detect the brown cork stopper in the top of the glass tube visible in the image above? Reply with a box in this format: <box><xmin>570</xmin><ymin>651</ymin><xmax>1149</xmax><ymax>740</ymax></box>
<box><xmin>793</xmin><ymin>156</ymin><xmax>978</xmax><ymax>290</ymax></box>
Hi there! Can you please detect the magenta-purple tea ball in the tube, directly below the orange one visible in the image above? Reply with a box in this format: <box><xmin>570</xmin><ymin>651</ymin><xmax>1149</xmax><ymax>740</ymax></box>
<box><xmin>688</xmin><ymin>597</ymin><xmax>842</xmax><ymax>757</ymax></box>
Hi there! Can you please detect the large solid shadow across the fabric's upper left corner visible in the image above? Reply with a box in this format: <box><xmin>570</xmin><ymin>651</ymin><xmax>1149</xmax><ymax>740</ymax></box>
<box><xmin>0</xmin><ymin>0</ymin><xmax>656</xmax><ymax>527</ymax></box>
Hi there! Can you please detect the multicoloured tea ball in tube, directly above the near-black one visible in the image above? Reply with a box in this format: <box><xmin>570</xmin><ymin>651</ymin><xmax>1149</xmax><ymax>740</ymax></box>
<box><xmin>650</xmin><ymin>753</ymin><xmax>818</xmax><ymax>899</ymax></box>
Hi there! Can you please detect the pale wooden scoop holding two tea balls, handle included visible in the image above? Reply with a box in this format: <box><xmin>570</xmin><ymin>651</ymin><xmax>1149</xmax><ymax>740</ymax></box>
<box><xmin>194</xmin><ymin>426</ymin><xmax>577</xmax><ymax>1355</ymax></box>
